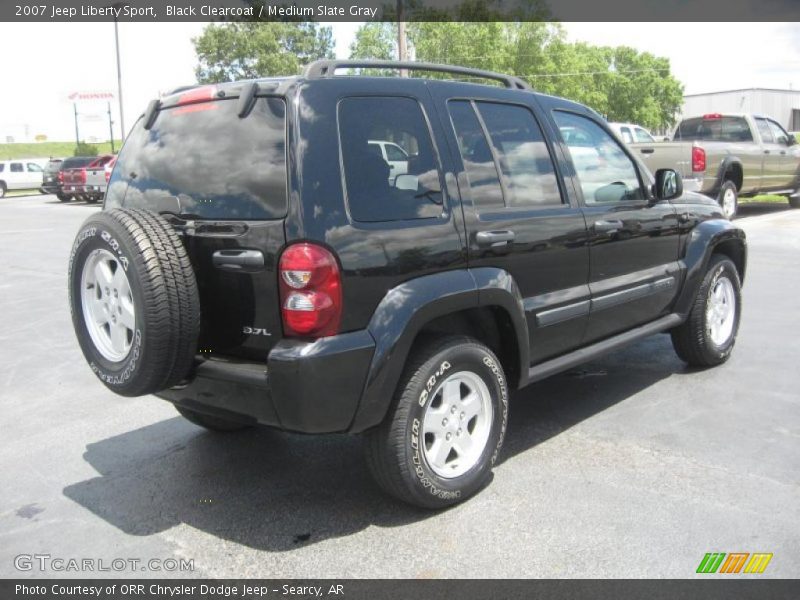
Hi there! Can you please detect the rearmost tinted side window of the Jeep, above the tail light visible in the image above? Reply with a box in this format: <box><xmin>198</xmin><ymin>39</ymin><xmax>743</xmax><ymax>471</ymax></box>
<box><xmin>339</xmin><ymin>97</ymin><xmax>444</xmax><ymax>222</ymax></box>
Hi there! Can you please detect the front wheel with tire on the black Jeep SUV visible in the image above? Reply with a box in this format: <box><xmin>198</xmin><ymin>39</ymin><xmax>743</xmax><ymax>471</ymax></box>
<box><xmin>671</xmin><ymin>254</ymin><xmax>742</xmax><ymax>367</ymax></box>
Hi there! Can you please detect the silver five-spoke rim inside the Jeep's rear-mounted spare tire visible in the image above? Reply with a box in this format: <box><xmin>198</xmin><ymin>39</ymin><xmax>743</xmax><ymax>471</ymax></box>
<box><xmin>81</xmin><ymin>249</ymin><xmax>136</xmax><ymax>362</ymax></box>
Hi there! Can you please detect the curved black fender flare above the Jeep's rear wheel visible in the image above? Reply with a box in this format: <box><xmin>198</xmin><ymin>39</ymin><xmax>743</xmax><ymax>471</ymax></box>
<box><xmin>349</xmin><ymin>267</ymin><xmax>530</xmax><ymax>433</ymax></box>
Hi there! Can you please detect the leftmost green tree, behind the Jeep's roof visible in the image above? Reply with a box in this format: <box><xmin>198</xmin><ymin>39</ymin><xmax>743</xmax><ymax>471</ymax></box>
<box><xmin>192</xmin><ymin>21</ymin><xmax>333</xmax><ymax>83</ymax></box>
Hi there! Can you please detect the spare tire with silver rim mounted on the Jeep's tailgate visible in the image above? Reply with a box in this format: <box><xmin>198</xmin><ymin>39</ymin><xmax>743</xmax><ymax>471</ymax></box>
<box><xmin>69</xmin><ymin>208</ymin><xmax>200</xmax><ymax>396</ymax></box>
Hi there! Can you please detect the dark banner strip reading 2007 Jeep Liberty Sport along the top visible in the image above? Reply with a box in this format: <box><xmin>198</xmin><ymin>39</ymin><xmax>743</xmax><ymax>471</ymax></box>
<box><xmin>0</xmin><ymin>0</ymin><xmax>800</xmax><ymax>22</ymax></box>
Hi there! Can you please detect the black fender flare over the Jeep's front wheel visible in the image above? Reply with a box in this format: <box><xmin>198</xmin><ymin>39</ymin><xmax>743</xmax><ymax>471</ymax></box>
<box><xmin>673</xmin><ymin>219</ymin><xmax>747</xmax><ymax>318</ymax></box>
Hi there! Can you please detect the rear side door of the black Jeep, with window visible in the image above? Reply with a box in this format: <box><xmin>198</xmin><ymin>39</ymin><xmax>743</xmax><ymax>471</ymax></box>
<box><xmin>431</xmin><ymin>85</ymin><xmax>589</xmax><ymax>364</ymax></box>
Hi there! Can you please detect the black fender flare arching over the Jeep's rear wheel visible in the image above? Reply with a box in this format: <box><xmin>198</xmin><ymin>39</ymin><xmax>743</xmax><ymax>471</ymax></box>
<box><xmin>350</xmin><ymin>268</ymin><xmax>530</xmax><ymax>432</ymax></box>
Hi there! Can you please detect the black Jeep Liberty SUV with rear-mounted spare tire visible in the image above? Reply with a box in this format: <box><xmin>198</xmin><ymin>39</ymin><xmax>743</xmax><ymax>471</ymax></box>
<box><xmin>69</xmin><ymin>61</ymin><xmax>746</xmax><ymax>508</ymax></box>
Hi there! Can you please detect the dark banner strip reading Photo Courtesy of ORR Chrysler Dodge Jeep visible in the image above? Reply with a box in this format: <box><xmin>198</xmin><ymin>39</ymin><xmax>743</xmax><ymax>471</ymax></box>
<box><xmin>0</xmin><ymin>578</ymin><xmax>800</xmax><ymax>600</ymax></box>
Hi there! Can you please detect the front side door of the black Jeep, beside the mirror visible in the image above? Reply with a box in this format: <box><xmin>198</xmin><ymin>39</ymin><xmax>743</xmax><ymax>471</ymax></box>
<box><xmin>552</xmin><ymin>110</ymin><xmax>681</xmax><ymax>343</ymax></box>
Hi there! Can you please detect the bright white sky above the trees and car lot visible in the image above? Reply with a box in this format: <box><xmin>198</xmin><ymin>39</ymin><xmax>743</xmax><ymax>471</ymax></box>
<box><xmin>0</xmin><ymin>22</ymin><xmax>800</xmax><ymax>142</ymax></box>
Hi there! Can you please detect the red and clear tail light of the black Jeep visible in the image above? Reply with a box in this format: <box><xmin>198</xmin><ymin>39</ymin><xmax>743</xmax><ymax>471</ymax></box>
<box><xmin>278</xmin><ymin>243</ymin><xmax>342</xmax><ymax>337</ymax></box>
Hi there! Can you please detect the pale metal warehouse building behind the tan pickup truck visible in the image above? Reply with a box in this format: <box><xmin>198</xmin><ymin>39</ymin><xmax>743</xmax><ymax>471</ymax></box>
<box><xmin>681</xmin><ymin>88</ymin><xmax>800</xmax><ymax>131</ymax></box>
